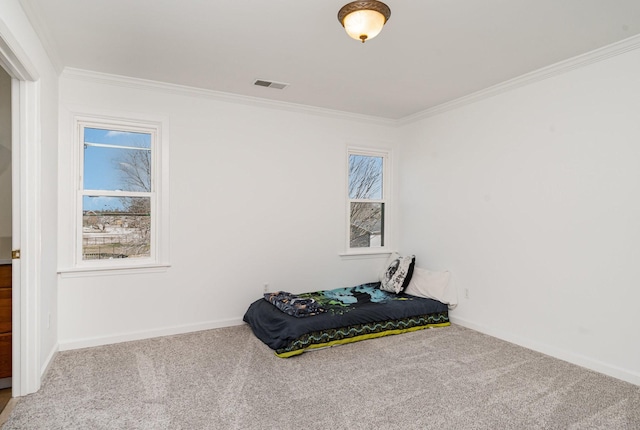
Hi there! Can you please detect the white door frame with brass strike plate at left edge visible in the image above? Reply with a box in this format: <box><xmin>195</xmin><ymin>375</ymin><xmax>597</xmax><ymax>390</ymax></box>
<box><xmin>0</xmin><ymin>19</ymin><xmax>41</xmax><ymax>397</ymax></box>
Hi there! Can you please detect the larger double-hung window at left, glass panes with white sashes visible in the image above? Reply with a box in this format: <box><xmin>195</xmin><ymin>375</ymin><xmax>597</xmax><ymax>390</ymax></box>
<box><xmin>76</xmin><ymin>116</ymin><xmax>168</xmax><ymax>267</ymax></box>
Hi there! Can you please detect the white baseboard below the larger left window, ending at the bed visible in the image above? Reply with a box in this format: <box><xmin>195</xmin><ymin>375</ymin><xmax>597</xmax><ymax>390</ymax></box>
<box><xmin>59</xmin><ymin>318</ymin><xmax>244</xmax><ymax>351</ymax></box>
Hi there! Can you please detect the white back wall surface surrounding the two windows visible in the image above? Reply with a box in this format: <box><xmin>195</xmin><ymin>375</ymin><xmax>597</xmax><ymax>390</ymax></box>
<box><xmin>59</xmin><ymin>73</ymin><xmax>397</xmax><ymax>349</ymax></box>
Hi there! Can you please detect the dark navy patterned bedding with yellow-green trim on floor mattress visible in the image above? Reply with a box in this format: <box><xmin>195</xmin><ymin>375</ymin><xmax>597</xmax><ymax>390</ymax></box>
<box><xmin>243</xmin><ymin>282</ymin><xmax>449</xmax><ymax>357</ymax></box>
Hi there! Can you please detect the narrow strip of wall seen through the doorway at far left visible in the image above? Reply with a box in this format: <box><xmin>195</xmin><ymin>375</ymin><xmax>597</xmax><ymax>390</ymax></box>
<box><xmin>0</xmin><ymin>67</ymin><xmax>11</xmax><ymax>260</ymax></box>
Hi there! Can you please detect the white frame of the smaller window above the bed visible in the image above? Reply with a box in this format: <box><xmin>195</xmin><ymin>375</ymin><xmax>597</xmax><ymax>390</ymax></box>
<box><xmin>341</xmin><ymin>146</ymin><xmax>393</xmax><ymax>256</ymax></box>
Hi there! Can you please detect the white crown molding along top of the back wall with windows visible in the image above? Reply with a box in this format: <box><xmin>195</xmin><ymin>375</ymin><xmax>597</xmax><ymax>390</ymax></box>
<box><xmin>62</xmin><ymin>67</ymin><xmax>397</xmax><ymax>126</ymax></box>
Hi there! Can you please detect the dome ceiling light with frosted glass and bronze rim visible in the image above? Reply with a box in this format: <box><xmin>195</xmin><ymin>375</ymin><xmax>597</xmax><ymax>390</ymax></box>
<box><xmin>338</xmin><ymin>0</ymin><xmax>391</xmax><ymax>43</ymax></box>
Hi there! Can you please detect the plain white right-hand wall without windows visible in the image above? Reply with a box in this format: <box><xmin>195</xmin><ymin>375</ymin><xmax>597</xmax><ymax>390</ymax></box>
<box><xmin>399</xmin><ymin>50</ymin><xmax>640</xmax><ymax>384</ymax></box>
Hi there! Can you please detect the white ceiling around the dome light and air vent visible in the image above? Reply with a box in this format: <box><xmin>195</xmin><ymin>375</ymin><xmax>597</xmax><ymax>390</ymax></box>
<box><xmin>21</xmin><ymin>0</ymin><xmax>640</xmax><ymax>119</ymax></box>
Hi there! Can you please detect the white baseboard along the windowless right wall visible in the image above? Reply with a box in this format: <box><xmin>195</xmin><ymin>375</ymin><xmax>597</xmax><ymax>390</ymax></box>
<box><xmin>449</xmin><ymin>315</ymin><xmax>640</xmax><ymax>386</ymax></box>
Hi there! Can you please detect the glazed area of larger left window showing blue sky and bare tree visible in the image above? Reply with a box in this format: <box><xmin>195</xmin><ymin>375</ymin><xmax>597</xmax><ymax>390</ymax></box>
<box><xmin>81</xmin><ymin>125</ymin><xmax>155</xmax><ymax>260</ymax></box>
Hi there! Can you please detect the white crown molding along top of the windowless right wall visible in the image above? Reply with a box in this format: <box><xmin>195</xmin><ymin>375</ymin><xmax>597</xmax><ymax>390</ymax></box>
<box><xmin>397</xmin><ymin>35</ymin><xmax>640</xmax><ymax>125</ymax></box>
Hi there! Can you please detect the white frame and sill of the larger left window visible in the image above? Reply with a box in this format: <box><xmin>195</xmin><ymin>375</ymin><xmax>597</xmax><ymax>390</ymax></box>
<box><xmin>59</xmin><ymin>114</ymin><xmax>170</xmax><ymax>276</ymax></box>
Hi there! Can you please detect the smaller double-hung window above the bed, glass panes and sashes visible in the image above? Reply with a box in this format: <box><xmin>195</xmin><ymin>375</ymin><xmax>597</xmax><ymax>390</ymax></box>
<box><xmin>348</xmin><ymin>149</ymin><xmax>389</xmax><ymax>250</ymax></box>
